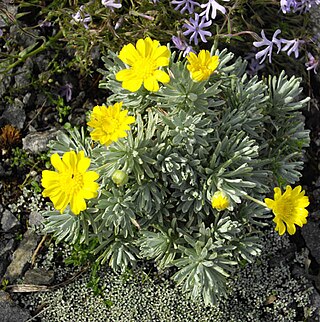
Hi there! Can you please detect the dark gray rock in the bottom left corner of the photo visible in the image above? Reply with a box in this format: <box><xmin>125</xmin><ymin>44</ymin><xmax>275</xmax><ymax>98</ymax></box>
<box><xmin>0</xmin><ymin>291</ymin><xmax>31</xmax><ymax>322</ymax></box>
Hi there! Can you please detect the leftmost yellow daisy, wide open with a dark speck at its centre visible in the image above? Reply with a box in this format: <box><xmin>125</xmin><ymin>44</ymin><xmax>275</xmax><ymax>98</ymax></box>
<box><xmin>41</xmin><ymin>151</ymin><xmax>99</xmax><ymax>215</ymax></box>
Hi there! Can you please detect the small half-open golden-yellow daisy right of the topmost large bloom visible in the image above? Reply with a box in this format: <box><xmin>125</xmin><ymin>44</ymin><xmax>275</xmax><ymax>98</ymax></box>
<box><xmin>187</xmin><ymin>50</ymin><xmax>219</xmax><ymax>82</ymax></box>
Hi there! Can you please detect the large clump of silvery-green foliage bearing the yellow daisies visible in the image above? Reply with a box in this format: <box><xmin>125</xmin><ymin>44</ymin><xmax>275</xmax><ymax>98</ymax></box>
<box><xmin>45</xmin><ymin>50</ymin><xmax>309</xmax><ymax>304</ymax></box>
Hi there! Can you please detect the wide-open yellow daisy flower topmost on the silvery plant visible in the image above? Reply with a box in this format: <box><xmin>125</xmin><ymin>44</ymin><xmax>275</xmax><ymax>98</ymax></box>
<box><xmin>116</xmin><ymin>37</ymin><xmax>170</xmax><ymax>92</ymax></box>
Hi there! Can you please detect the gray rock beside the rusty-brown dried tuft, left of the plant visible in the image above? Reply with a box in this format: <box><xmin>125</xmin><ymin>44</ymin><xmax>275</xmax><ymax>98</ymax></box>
<box><xmin>22</xmin><ymin>130</ymin><xmax>60</xmax><ymax>154</ymax></box>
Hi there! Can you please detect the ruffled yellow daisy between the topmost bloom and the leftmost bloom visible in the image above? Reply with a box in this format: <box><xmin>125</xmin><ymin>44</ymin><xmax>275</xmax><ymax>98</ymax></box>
<box><xmin>87</xmin><ymin>102</ymin><xmax>135</xmax><ymax>145</ymax></box>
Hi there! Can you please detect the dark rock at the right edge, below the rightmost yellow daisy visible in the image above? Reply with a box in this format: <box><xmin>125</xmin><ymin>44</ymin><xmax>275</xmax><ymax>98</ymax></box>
<box><xmin>301</xmin><ymin>221</ymin><xmax>320</xmax><ymax>264</ymax></box>
